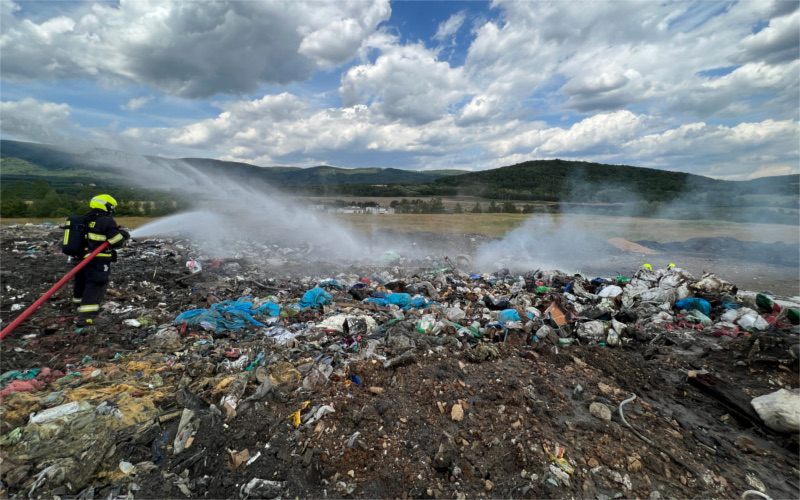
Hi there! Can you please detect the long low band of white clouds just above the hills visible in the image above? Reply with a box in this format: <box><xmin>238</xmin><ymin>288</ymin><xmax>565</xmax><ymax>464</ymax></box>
<box><xmin>6</xmin><ymin>93</ymin><xmax>800</xmax><ymax>179</ymax></box>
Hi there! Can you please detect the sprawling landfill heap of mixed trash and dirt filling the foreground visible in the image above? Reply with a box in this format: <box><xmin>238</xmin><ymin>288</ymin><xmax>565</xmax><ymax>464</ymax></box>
<box><xmin>0</xmin><ymin>226</ymin><xmax>800</xmax><ymax>500</ymax></box>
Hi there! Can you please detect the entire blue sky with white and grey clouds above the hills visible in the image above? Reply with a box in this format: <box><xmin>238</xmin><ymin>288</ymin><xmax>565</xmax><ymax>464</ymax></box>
<box><xmin>0</xmin><ymin>0</ymin><xmax>800</xmax><ymax>180</ymax></box>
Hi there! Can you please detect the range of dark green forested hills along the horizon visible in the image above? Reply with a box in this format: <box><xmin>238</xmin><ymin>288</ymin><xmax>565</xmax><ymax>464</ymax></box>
<box><xmin>0</xmin><ymin>140</ymin><xmax>800</xmax><ymax>203</ymax></box>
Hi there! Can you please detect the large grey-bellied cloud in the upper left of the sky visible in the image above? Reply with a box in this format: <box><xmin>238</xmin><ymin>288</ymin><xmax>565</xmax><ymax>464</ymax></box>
<box><xmin>0</xmin><ymin>0</ymin><xmax>391</xmax><ymax>98</ymax></box>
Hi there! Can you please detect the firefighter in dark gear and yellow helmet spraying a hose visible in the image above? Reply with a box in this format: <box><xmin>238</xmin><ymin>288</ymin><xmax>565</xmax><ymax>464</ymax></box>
<box><xmin>72</xmin><ymin>194</ymin><xmax>131</xmax><ymax>326</ymax></box>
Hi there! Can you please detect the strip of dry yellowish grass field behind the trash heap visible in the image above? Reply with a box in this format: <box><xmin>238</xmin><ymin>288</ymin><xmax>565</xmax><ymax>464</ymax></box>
<box><xmin>0</xmin><ymin>214</ymin><xmax>800</xmax><ymax>243</ymax></box>
